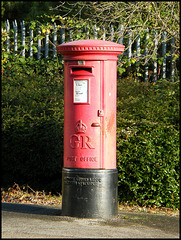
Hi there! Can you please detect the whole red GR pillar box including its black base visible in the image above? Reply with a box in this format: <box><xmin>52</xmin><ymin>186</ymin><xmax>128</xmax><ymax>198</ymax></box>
<box><xmin>57</xmin><ymin>39</ymin><xmax>124</xmax><ymax>218</ymax></box>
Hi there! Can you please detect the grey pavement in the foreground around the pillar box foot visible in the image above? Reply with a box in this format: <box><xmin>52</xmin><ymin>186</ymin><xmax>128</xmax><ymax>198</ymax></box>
<box><xmin>1</xmin><ymin>203</ymin><xmax>180</xmax><ymax>239</ymax></box>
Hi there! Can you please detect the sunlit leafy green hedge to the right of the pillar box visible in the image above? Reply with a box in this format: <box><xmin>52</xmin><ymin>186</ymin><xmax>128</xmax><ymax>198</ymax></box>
<box><xmin>117</xmin><ymin>80</ymin><xmax>180</xmax><ymax>208</ymax></box>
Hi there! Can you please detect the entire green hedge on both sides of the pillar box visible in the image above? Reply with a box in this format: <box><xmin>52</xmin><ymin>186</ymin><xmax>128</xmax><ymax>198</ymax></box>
<box><xmin>2</xmin><ymin>60</ymin><xmax>180</xmax><ymax>208</ymax></box>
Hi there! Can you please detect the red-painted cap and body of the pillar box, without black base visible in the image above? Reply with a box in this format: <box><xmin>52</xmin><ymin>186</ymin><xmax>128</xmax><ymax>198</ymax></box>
<box><xmin>57</xmin><ymin>40</ymin><xmax>124</xmax><ymax>169</ymax></box>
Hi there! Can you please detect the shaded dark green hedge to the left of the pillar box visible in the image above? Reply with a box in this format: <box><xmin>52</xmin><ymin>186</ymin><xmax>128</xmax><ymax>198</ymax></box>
<box><xmin>2</xmin><ymin>60</ymin><xmax>64</xmax><ymax>192</ymax></box>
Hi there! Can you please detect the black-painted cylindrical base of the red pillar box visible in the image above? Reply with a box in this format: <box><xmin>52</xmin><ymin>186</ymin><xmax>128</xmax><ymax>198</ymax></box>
<box><xmin>62</xmin><ymin>168</ymin><xmax>118</xmax><ymax>218</ymax></box>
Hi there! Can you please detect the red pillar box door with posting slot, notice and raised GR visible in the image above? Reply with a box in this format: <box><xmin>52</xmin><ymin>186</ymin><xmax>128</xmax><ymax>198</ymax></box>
<box><xmin>64</xmin><ymin>61</ymin><xmax>103</xmax><ymax>169</ymax></box>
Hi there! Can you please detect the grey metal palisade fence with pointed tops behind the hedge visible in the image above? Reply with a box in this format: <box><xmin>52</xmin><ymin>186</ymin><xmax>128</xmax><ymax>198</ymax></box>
<box><xmin>2</xmin><ymin>20</ymin><xmax>179</xmax><ymax>83</ymax></box>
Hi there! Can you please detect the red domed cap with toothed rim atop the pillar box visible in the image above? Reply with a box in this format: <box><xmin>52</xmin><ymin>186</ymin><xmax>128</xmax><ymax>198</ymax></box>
<box><xmin>57</xmin><ymin>39</ymin><xmax>124</xmax><ymax>60</ymax></box>
